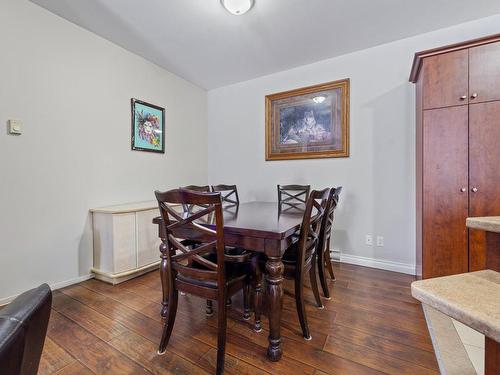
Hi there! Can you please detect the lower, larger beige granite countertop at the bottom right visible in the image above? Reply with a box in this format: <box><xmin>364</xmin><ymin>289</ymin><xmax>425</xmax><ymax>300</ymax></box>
<box><xmin>411</xmin><ymin>270</ymin><xmax>500</xmax><ymax>342</ymax></box>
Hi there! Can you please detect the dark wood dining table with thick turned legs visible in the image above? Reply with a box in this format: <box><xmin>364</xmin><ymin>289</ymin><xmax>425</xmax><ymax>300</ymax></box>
<box><xmin>153</xmin><ymin>202</ymin><xmax>303</xmax><ymax>361</ymax></box>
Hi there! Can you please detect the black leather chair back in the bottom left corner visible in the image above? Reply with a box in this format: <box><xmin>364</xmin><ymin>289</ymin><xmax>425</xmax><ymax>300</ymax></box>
<box><xmin>0</xmin><ymin>284</ymin><xmax>52</xmax><ymax>375</ymax></box>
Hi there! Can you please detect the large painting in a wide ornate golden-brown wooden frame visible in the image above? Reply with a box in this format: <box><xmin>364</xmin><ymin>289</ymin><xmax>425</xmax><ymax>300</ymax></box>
<box><xmin>266</xmin><ymin>79</ymin><xmax>349</xmax><ymax>160</ymax></box>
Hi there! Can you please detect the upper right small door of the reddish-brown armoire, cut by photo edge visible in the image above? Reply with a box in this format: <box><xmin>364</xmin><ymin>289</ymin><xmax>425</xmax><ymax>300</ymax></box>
<box><xmin>469</xmin><ymin>43</ymin><xmax>500</xmax><ymax>103</ymax></box>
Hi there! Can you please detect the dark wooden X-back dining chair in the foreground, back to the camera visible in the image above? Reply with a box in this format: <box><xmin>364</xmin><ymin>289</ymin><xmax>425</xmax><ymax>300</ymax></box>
<box><xmin>155</xmin><ymin>189</ymin><xmax>252</xmax><ymax>374</ymax></box>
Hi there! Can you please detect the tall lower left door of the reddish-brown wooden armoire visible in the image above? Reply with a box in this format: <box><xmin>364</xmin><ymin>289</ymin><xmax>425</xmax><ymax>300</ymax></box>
<box><xmin>422</xmin><ymin>106</ymin><xmax>468</xmax><ymax>278</ymax></box>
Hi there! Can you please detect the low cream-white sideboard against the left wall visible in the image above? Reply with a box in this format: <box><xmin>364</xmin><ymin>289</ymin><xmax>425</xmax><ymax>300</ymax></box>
<box><xmin>90</xmin><ymin>201</ymin><xmax>161</xmax><ymax>284</ymax></box>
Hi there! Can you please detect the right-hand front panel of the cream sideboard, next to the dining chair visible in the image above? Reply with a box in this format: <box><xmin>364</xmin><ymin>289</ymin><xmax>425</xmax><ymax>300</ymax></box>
<box><xmin>136</xmin><ymin>209</ymin><xmax>161</xmax><ymax>267</ymax></box>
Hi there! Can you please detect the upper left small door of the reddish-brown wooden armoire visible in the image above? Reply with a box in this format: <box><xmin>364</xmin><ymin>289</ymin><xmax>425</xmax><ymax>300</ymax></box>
<box><xmin>422</xmin><ymin>49</ymin><xmax>469</xmax><ymax>109</ymax></box>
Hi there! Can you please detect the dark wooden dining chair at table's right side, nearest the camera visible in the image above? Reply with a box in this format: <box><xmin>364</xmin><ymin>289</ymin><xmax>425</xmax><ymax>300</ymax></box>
<box><xmin>255</xmin><ymin>188</ymin><xmax>330</xmax><ymax>340</ymax></box>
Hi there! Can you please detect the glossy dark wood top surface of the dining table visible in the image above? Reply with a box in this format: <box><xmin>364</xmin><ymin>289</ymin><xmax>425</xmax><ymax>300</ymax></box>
<box><xmin>153</xmin><ymin>202</ymin><xmax>304</xmax><ymax>240</ymax></box>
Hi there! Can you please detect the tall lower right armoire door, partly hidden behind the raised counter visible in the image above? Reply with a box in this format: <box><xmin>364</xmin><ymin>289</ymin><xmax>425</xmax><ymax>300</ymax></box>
<box><xmin>469</xmin><ymin>101</ymin><xmax>500</xmax><ymax>271</ymax></box>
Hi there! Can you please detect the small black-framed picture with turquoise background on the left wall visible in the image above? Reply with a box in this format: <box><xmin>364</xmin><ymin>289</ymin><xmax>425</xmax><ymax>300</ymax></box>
<box><xmin>131</xmin><ymin>99</ymin><xmax>165</xmax><ymax>154</ymax></box>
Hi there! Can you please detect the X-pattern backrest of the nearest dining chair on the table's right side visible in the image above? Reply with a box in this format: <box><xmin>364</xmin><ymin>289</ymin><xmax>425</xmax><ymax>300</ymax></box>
<box><xmin>297</xmin><ymin>188</ymin><xmax>330</xmax><ymax>273</ymax></box>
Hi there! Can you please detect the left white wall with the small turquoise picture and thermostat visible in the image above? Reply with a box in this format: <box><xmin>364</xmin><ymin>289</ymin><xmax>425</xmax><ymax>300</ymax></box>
<box><xmin>0</xmin><ymin>0</ymin><xmax>207</xmax><ymax>301</ymax></box>
